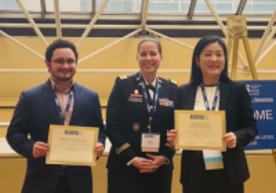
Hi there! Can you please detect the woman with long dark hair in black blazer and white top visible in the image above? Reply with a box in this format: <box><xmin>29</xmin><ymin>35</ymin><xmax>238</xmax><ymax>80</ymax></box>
<box><xmin>168</xmin><ymin>36</ymin><xmax>258</xmax><ymax>193</ymax></box>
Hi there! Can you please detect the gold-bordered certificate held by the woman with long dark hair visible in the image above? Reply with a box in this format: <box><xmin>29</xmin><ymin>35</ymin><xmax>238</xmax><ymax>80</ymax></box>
<box><xmin>175</xmin><ymin>110</ymin><xmax>226</xmax><ymax>151</ymax></box>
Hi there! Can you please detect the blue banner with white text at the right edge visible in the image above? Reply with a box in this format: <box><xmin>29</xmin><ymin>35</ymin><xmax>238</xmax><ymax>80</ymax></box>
<box><xmin>244</xmin><ymin>80</ymin><xmax>276</xmax><ymax>150</ymax></box>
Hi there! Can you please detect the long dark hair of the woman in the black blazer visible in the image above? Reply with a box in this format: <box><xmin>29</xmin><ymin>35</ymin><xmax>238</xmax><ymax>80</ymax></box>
<box><xmin>190</xmin><ymin>36</ymin><xmax>230</xmax><ymax>85</ymax></box>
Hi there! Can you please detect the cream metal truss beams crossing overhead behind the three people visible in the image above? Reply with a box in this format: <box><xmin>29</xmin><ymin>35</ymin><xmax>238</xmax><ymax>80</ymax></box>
<box><xmin>0</xmin><ymin>0</ymin><xmax>276</xmax><ymax>73</ymax></box>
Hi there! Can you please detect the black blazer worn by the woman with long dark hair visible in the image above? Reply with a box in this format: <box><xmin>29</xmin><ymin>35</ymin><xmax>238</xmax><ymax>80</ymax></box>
<box><xmin>177</xmin><ymin>81</ymin><xmax>258</xmax><ymax>186</ymax></box>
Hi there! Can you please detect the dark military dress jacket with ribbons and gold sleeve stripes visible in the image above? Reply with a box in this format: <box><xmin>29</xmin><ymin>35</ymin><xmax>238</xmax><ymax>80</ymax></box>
<box><xmin>106</xmin><ymin>73</ymin><xmax>177</xmax><ymax>171</ymax></box>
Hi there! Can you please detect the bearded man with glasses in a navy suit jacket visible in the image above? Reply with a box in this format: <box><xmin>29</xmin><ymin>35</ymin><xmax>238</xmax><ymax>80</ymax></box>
<box><xmin>6</xmin><ymin>40</ymin><xmax>105</xmax><ymax>193</ymax></box>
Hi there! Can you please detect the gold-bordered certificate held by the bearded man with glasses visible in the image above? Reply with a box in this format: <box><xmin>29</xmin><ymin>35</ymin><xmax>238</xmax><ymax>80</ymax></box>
<box><xmin>46</xmin><ymin>125</ymin><xmax>99</xmax><ymax>166</ymax></box>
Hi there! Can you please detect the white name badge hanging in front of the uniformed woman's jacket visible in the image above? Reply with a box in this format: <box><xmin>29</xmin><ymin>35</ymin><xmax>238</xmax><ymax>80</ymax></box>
<box><xmin>141</xmin><ymin>133</ymin><xmax>160</xmax><ymax>152</ymax></box>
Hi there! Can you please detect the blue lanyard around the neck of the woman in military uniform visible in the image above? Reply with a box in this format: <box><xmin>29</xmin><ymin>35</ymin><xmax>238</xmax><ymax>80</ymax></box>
<box><xmin>140</xmin><ymin>73</ymin><xmax>159</xmax><ymax>131</ymax></box>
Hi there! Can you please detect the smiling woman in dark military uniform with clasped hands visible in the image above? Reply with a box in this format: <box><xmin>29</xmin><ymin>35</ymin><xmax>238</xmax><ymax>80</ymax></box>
<box><xmin>107</xmin><ymin>38</ymin><xmax>177</xmax><ymax>193</ymax></box>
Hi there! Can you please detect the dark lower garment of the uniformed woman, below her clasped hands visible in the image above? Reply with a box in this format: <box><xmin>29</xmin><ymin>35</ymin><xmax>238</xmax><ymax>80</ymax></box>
<box><xmin>108</xmin><ymin>168</ymin><xmax>172</xmax><ymax>193</ymax></box>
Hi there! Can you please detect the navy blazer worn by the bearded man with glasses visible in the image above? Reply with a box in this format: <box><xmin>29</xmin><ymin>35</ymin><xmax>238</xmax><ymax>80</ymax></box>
<box><xmin>6</xmin><ymin>80</ymin><xmax>105</xmax><ymax>193</ymax></box>
